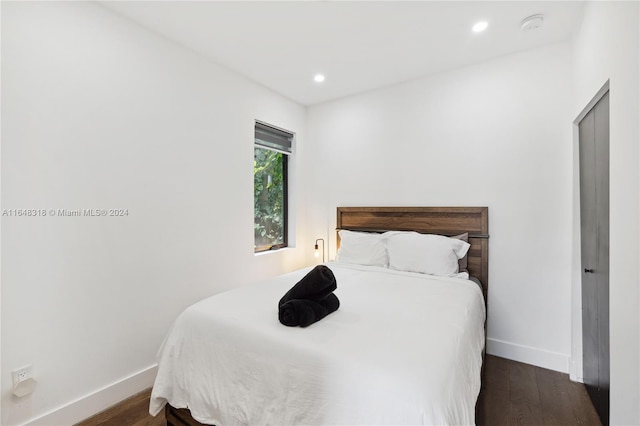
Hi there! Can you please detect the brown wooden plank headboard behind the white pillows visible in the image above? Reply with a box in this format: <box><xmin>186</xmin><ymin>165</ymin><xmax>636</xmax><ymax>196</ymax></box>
<box><xmin>336</xmin><ymin>207</ymin><xmax>489</xmax><ymax>300</ymax></box>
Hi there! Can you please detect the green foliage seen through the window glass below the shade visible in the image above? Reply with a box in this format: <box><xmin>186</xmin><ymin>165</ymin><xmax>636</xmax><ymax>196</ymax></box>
<box><xmin>253</xmin><ymin>147</ymin><xmax>286</xmax><ymax>249</ymax></box>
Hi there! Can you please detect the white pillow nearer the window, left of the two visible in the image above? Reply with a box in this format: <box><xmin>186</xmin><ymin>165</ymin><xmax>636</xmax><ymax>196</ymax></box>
<box><xmin>336</xmin><ymin>229</ymin><xmax>388</xmax><ymax>267</ymax></box>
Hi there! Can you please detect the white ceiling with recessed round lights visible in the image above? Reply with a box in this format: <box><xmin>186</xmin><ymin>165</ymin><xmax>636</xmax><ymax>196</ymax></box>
<box><xmin>101</xmin><ymin>0</ymin><xmax>584</xmax><ymax>105</ymax></box>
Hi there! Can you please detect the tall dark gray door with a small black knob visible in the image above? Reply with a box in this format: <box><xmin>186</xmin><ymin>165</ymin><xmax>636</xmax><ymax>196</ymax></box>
<box><xmin>579</xmin><ymin>92</ymin><xmax>609</xmax><ymax>425</ymax></box>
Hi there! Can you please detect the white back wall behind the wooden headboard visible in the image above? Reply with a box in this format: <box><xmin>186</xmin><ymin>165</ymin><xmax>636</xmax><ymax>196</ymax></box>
<box><xmin>304</xmin><ymin>44</ymin><xmax>573</xmax><ymax>371</ymax></box>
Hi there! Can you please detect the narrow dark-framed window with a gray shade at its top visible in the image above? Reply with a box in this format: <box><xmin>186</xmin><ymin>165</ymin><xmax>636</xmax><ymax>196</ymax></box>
<box><xmin>253</xmin><ymin>121</ymin><xmax>293</xmax><ymax>252</ymax></box>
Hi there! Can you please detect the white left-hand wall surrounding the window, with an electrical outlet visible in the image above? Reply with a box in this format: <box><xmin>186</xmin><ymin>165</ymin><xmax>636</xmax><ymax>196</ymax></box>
<box><xmin>0</xmin><ymin>2</ymin><xmax>313</xmax><ymax>425</ymax></box>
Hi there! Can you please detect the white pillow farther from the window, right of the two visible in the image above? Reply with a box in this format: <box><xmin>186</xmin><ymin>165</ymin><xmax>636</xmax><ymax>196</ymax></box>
<box><xmin>387</xmin><ymin>232</ymin><xmax>471</xmax><ymax>277</ymax></box>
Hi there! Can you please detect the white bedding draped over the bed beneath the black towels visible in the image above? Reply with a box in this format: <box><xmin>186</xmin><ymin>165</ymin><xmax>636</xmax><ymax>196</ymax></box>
<box><xmin>149</xmin><ymin>263</ymin><xmax>485</xmax><ymax>426</ymax></box>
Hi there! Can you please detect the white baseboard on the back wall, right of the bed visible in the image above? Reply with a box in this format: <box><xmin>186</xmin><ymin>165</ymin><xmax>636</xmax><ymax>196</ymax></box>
<box><xmin>487</xmin><ymin>338</ymin><xmax>570</xmax><ymax>374</ymax></box>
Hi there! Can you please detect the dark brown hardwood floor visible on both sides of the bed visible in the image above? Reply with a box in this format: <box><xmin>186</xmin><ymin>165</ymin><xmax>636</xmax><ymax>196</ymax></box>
<box><xmin>77</xmin><ymin>355</ymin><xmax>601</xmax><ymax>426</ymax></box>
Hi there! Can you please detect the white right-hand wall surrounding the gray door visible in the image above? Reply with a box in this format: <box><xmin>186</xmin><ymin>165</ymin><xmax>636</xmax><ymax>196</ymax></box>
<box><xmin>572</xmin><ymin>2</ymin><xmax>640</xmax><ymax>425</ymax></box>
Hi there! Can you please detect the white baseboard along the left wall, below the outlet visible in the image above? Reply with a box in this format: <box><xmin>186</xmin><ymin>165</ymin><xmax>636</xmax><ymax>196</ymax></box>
<box><xmin>25</xmin><ymin>364</ymin><xmax>158</xmax><ymax>426</ymax></box>
